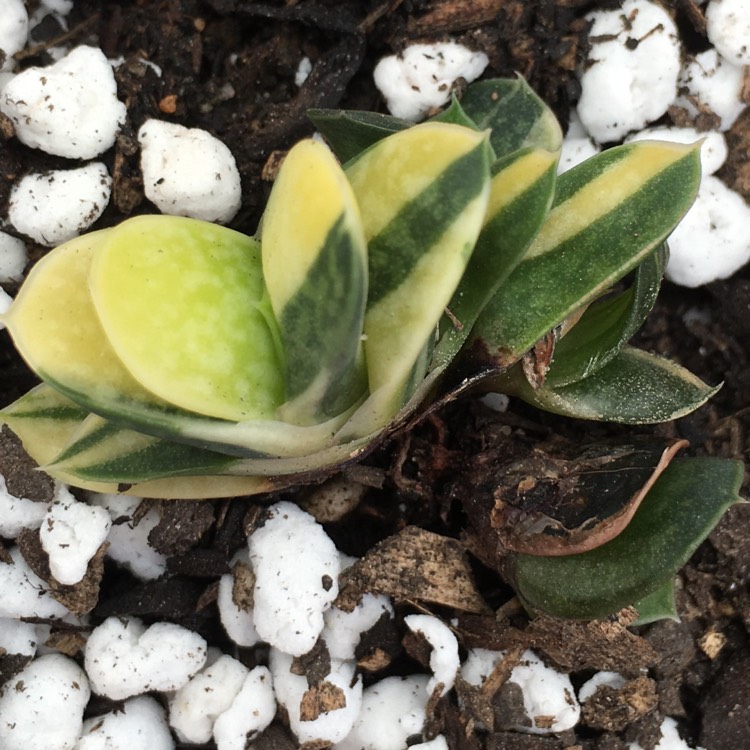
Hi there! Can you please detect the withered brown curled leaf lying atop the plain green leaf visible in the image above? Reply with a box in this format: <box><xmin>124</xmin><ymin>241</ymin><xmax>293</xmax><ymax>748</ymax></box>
<box><xmin>463</xmin><ymin>440</ymin><xmax>687</xmax><ymax>561</ymax></box>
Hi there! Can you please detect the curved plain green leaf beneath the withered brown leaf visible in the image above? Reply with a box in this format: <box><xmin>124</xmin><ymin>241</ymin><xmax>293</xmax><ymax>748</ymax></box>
<box><xmin>508</xmin><ymin>458</ymin><xmax>743</xmax><ymax>619</ymax></box>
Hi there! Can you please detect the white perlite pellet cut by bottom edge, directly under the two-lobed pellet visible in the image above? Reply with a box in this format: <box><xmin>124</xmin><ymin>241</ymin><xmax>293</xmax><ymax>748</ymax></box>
<box><xmin>75</xmin><ymin>696</ymin><xmax>174</xmax><ymax>750</ymax></box>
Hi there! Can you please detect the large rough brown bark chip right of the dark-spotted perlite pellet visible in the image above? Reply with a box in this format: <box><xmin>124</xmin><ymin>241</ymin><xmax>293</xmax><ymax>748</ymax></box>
<box><xmin>334</xmin><ymin>526</ymin><xmax>488</xmax><ymax>613</ymax></box>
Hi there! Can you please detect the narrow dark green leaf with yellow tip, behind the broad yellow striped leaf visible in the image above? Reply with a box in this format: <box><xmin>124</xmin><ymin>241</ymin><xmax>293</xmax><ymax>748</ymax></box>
<box><xmin>432</xmin><ymin>149</ymin><xmax>558</xmax><ymax>367</ymax></box>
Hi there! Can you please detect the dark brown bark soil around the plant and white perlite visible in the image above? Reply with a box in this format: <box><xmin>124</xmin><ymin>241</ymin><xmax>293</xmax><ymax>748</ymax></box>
<box><xmin>0</xmin><ymin>0</ymin><xmax>750</xmax><ymax>750</ymax></box>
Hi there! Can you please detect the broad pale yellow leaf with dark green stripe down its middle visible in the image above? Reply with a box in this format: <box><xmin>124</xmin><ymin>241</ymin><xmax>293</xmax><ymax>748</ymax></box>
<box><xmin>347</xmin><ymin>123</ymin><xmax>490</xmax><ymax>424</ymax></box>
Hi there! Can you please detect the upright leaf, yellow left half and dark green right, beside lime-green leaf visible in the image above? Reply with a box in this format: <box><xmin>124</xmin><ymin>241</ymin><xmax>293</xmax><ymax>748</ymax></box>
<box><xmin>261</xmin><ymin>140</ymin><xmax>367</xmax><ymax>424</ymax></box>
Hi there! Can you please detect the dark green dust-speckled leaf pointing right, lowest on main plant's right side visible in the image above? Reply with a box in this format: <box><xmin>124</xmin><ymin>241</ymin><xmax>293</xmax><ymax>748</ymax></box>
<box><xmin>493</xmin><ymin>346</ymin><xmax>721</xmax><ymax>424</ymax></box>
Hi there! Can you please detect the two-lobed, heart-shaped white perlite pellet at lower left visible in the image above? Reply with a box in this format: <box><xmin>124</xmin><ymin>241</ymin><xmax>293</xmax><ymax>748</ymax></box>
<box><xmin>85</xmin><ymin>617</ymin><xmax>206</xmax><ymax>700</ymax></box>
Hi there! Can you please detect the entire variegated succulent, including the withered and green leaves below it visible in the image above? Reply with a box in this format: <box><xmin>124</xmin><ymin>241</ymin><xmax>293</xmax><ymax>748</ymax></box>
<box><xmin>1</xmin><ymin>80</ymin><xmax>742</xmax><ymax>619</ymax></box>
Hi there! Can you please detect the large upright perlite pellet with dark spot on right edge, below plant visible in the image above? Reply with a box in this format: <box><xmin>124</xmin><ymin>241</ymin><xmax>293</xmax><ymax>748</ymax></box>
<box><xmin>248</xmin><ymin>501</ymin><xmax>340</xmax><ymax>656</ymax></box>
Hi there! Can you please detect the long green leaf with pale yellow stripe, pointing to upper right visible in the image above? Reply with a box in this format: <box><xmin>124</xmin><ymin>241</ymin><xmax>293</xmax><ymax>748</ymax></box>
<box><xmin>472</xmin><ymin>141</ymin><xmax>700</xmax><ymax>367</ymax></box>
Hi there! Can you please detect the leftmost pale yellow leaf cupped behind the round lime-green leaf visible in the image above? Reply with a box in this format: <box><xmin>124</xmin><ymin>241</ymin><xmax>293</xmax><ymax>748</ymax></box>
<box><xmin>3</xmin><ymin>217</ymin><xmax>362</xmax><ymax>456</ymax></box>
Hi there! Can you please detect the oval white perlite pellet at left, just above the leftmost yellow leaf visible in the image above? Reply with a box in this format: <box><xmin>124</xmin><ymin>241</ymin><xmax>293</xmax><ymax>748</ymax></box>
<box><xmin>8</xmin><ymin>162</ymin><xmax>112</xmax><ymax>247</ymax></box>
